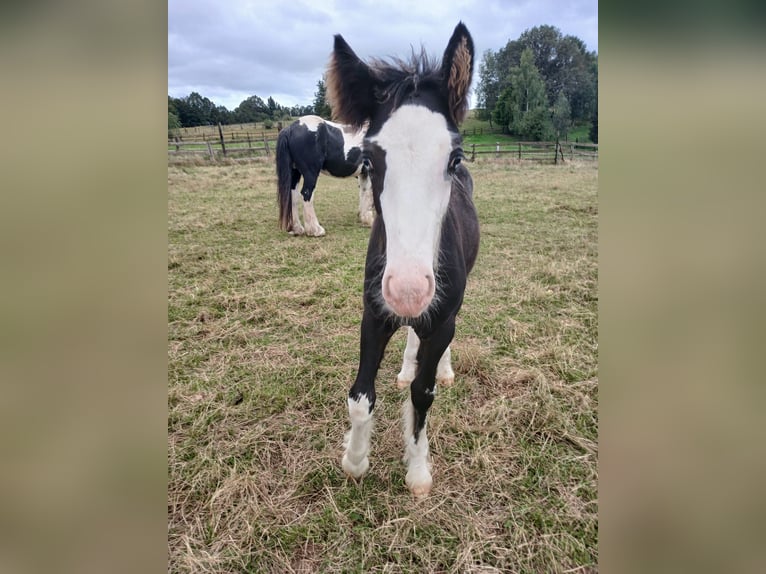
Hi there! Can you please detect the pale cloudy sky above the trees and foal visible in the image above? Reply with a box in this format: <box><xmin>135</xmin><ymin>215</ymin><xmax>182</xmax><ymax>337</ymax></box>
<box><xmin>168</xmin><ymin>0</ymin><xmax>598</xmax><ymax>111</ymax></box>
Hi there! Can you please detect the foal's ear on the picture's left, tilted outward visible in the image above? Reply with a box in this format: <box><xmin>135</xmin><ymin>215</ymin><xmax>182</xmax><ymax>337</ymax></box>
<box><xmin>326</xmin><ymin>34</ymin><xmax>375</xmax><ymax>127</ymax></box>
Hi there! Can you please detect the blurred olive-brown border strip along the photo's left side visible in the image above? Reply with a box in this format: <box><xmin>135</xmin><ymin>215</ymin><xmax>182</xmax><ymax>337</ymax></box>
<box><xmin>0</xmin><ymin>0</ymin><xmax>167</xmax><ymax>573</ymax></box>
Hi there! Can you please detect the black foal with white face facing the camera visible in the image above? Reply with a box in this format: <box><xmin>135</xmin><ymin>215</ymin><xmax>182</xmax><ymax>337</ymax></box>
<box><xmin>327</xmin><ymin>22</ymin><xmax>479</xmax><ymax>497</ymax></box>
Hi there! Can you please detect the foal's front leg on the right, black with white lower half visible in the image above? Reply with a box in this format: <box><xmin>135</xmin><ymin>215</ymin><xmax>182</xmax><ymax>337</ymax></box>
<box><xmin>402</xmin><ymin>317</ymin><xmax>455</xmax><ymax>497</ymax></box>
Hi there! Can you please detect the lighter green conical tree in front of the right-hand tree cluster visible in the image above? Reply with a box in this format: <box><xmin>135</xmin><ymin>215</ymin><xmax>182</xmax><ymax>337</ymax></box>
<box><xmin>495</xmin><ymin>49</ymin><xmax>553</xmax><ymax>140</ymax></box>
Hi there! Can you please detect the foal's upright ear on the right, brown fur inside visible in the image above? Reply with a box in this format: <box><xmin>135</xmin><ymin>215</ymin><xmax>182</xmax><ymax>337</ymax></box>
<box><xmin>442</xmin><ymin>22</ymin><xmax>473</xmax><ymax>125</ymax></box>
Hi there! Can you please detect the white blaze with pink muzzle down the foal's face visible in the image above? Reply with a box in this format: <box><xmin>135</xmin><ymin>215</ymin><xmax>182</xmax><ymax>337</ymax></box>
<box><xmin>372</xmin><ymin>105</ymin><xmax>452</xmax><ymax>317</ymax></box>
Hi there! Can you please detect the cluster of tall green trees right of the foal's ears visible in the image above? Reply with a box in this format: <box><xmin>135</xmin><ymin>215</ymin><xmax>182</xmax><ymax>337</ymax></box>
<box><xmin>476</xmin><ymin>25</ymin><xmax>598</xmax><ymax>143</ymax></box>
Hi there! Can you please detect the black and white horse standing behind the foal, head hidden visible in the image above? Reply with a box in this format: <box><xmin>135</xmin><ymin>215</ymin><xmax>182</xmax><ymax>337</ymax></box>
<box><xmin>277</xmin><ymin>116</ymin><xmax>375</xmax><ymax>237</ymax></box>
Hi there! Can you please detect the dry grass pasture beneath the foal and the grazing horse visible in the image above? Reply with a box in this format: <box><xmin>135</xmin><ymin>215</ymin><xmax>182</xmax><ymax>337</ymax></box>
<box><xmin>168</xmin><ymin>157</ymin><xmax>598</xmax><ymax>574</ymax></box>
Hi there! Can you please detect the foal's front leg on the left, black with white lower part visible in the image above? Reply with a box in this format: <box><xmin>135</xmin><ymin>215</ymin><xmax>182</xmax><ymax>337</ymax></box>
<box><xmin>342</xmin><ymin>310</ymin><xmax>395</xmax><ymax>478</ymax></box>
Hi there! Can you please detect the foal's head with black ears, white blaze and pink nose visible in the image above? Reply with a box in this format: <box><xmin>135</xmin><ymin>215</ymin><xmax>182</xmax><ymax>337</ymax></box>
<box><xmin>327</xmin><ymin>22</ymin><xmax>474</xmax><ymax>317</ymax></box>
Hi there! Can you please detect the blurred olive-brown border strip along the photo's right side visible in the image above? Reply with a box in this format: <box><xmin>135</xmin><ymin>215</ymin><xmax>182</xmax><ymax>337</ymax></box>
<box><xmin>599</xmin><ymin>1</ymin><xmax>766</xmax><ymax>572</ymax></box>
